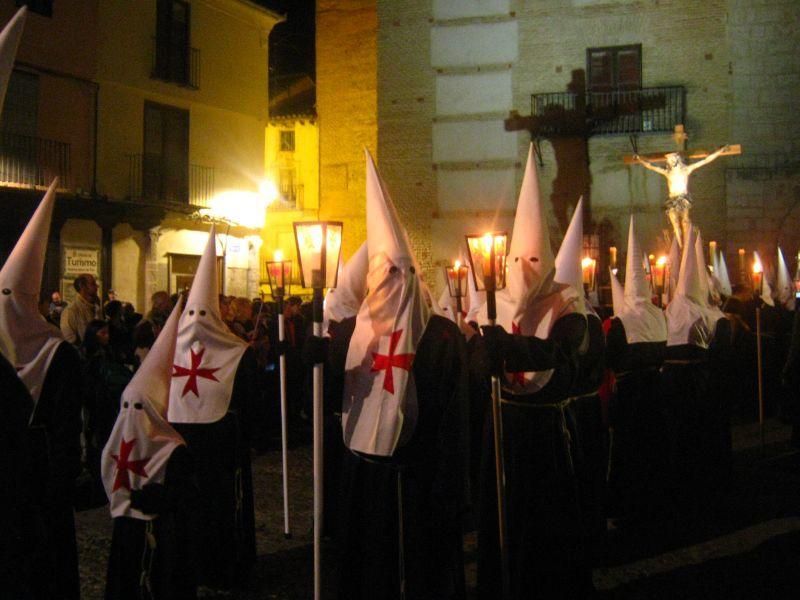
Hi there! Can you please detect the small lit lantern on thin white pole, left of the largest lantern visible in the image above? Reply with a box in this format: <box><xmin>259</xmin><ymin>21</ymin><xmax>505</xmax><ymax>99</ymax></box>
<box><xmin>267</xmin><ymin>250</ymin><xmax>292</xmax><ymax>539</ymax></box>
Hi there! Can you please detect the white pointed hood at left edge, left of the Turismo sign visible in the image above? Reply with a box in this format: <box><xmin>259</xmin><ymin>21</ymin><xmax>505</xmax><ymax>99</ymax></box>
<box><xmin>0</xmin><ymin>179</ymin><xmax>63</xmax><ymax>406</ymax></box>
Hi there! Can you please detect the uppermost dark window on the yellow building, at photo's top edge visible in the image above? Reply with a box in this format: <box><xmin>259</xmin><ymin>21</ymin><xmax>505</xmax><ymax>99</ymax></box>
<box><xmin>153</xmin><ymin>0</ymin><xmax>191</xmax><ymax>85</ymax></box>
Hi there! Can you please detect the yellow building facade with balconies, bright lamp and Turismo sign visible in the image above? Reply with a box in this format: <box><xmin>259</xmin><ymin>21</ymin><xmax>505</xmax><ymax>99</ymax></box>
<box><xmin>0</xmin><ymin>0</ymin><xmax>281</xmax><ymax>311</ymax></box>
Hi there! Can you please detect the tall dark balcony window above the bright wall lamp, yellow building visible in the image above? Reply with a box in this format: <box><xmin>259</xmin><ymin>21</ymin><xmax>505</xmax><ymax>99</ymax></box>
<box><xmin>142</xmin><ymin>102</ymin><xmax>189</xmax><ymax>203</ymax></box>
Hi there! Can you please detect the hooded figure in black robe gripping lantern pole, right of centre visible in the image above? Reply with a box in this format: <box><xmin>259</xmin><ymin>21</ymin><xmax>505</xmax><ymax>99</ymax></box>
<box><xmin>478</xmin><ymin>147</ymin><xmax>592</xmax><ymax>599</ymax></box>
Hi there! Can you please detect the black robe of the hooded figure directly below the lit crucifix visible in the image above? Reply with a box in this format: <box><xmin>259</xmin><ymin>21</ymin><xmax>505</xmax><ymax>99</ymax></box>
<box><xmin>659</xmin><ymin>318</ymin><xmax>732</xmax><ymax>518</ymax></box>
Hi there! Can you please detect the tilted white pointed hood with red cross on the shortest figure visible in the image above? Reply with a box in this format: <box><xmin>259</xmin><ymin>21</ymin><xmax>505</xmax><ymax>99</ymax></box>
<box><xmin>101</xmin><ymin>299</ymin><xmax>186</xmax><ymax>520</ymax></box>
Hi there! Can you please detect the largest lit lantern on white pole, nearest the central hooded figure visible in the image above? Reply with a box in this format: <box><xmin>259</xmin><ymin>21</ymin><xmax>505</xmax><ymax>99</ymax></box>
<box><xmin>294</xmin><ymin>221</ymin><xmax>342</xmax><ymax>600</ymax></box>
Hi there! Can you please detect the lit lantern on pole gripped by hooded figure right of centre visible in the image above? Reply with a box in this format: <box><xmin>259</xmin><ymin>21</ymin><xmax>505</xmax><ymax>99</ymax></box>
<box><xmin>466</xmin><ymin>231</ymin><xmax>510</xmax><ymax>598</ymax></box>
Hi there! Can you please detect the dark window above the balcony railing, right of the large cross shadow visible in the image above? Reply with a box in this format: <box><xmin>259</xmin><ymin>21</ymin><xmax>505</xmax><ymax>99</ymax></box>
<box><xmin>586</xmin><ymin>44</ymin><xmax>642</xmax><ymax>92</ymax></box>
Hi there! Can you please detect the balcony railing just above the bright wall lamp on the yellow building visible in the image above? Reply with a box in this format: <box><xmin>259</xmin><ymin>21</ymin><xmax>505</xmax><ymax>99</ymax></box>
<box><xmin>128</xmin><ymin>154</ymin><xmax>214</xmax><ymax>207</ymax></box>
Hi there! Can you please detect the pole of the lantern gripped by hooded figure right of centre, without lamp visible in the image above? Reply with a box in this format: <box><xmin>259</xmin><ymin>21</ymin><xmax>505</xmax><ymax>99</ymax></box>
<box><xmin>485</xmin><ymin>278</ymin><xmax>511</xmax><ymax>598</ymax></box>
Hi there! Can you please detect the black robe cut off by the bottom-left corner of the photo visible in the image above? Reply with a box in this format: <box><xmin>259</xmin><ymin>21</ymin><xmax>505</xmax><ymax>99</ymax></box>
<box><xmin>0</xmin><ymin>354</ymin><xmax>50</xmax><ymax>599</ymax></box>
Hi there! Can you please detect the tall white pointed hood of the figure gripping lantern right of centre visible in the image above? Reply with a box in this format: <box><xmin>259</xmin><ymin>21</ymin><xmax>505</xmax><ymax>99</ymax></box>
<box><xmin>478</xmin><ymin>145</ymin><xmax>580</xmax><ymax>395</ymax></box>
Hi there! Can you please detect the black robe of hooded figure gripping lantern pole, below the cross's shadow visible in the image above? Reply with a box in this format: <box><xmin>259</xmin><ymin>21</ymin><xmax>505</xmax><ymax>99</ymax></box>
<box><xmin>478</xmin><ymin>314</ymin><xmax>593</xmax><ymax>600</ymax></box>
